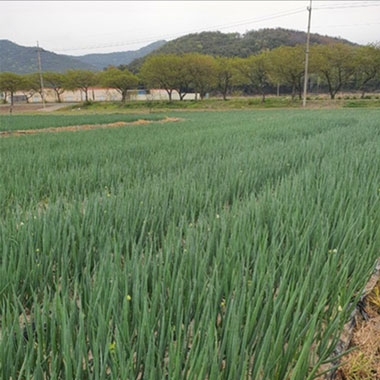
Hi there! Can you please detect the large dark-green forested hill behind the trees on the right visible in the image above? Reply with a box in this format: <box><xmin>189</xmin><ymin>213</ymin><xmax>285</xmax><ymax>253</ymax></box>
<box><xmin>129</xmin><ymin>28</ymin><xmax>354</xmax><ymax>70</ymax></box>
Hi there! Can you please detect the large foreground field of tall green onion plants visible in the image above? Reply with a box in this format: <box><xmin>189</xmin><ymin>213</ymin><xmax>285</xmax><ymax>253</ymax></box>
<box><xmin>0</xmin><ymin>110</ymin><xmax>380</xmax><ymax>380</ymax></box>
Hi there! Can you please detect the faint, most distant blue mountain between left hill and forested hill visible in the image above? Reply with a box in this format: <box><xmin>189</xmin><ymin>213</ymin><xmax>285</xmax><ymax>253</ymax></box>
<box><xmin>72</xmin><ymin>40</ymin><xmax>166</xmax><ymax>70</ymax></box>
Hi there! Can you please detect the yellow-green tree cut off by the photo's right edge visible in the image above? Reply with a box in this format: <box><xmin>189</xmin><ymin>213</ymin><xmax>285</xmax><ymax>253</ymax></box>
<box><xmin>354</xmin><ymin>45</ymin><xmax>380</xmax><ymax>98</ymax></box>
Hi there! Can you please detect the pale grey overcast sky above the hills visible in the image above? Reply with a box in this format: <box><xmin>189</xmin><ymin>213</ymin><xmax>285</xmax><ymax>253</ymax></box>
<box><xmin>0</xmin><ymin>0</ymin><xmax>380</xmax><ymax>55</ymax></box>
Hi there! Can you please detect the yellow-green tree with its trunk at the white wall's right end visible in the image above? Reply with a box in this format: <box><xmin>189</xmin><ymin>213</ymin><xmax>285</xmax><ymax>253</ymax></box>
<box><xmin>183</xmin><ymin>53</ymin><xmax>217</xmax><ymax>99</ymax></box>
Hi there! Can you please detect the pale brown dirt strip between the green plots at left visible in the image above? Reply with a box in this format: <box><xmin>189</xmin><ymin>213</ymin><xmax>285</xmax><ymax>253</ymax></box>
<box><xmin>0</xmin><ymin>117</ymin><xmax>182</xmax><ymax>138</ymax></box>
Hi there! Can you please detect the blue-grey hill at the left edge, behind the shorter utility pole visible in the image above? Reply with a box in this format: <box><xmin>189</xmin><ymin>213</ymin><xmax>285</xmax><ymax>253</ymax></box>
<box><xmin>0</xmin><ymin>40</ymin><xmax>96</xmax><ymax>74</ymax></box>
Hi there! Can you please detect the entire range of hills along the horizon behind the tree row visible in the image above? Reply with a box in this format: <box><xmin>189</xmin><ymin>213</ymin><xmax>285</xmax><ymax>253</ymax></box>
<box><xmin>0</xmin><ymin>28</ymin><xmax>354</xmax><ymax>74</ymax></box>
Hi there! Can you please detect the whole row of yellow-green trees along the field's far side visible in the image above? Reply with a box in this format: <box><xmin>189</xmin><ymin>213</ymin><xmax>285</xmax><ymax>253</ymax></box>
<box><xmin>0</xmin><ymin>43</ymin><xmax>380</xmax><ymax>103</ymax></box>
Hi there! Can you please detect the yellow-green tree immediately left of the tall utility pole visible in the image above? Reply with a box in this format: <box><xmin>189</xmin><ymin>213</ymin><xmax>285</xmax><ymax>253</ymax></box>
<box><xmin>268</xmin><ymin>45</ymin><xmax>305</xmax><ymax>100</ymax></box>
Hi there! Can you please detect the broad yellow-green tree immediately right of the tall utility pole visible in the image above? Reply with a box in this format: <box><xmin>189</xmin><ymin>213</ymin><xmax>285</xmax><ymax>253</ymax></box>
<box><xmin>309</xmin><ymin>43</ymin><xmax>356</xmax><ymax>99</ymax></box>
